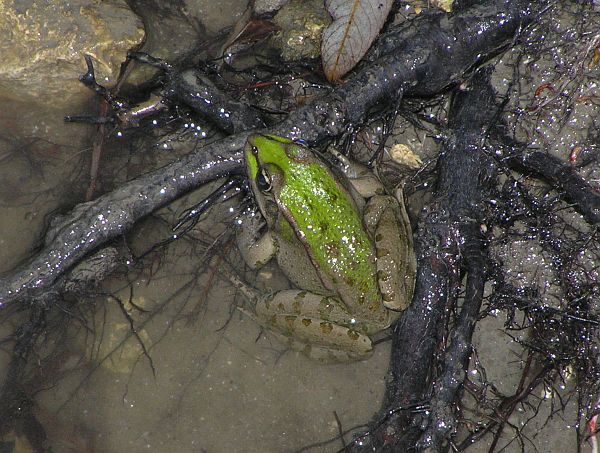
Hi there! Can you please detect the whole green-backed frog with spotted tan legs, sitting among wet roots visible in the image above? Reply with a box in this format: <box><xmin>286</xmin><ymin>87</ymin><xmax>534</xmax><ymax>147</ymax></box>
<box><xmin>237</xmin><ymin>133</ymin><xmax>416</xmax><ymax>363</ymax></box>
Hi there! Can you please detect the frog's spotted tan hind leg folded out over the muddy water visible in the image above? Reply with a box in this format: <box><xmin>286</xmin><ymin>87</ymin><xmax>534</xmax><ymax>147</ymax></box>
<box><xmin>254</xmin><ymin>289</ymin><xmax>373</xmax><ymax>362</ymax></box>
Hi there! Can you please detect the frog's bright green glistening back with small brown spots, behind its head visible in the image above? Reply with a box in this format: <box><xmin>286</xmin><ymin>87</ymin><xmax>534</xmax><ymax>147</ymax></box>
<box><xmin>279</xmin><ymin>159</ymin><xmax>385</xmax><ymax>317</ymax></box>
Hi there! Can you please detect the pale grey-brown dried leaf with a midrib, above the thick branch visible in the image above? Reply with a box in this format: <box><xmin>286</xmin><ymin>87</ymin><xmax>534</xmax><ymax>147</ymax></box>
<box><xmin>321</xmin><ymin>0</ymin><xmax>393</xmax><ymax>82</ymax></box>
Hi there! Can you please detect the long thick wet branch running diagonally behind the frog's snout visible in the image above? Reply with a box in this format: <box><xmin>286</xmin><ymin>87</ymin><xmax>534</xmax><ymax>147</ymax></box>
<box><xmin>0</xmin><ymin>0</ymin><xmax>544</xmax><ymax>307</ymax></box>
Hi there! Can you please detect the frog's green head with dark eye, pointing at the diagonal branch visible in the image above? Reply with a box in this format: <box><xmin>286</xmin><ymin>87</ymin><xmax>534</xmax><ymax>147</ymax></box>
<box><xmin>244</xmin><ymin>134</ymin><xmax>297</xmax><ymax>224</ymax></box>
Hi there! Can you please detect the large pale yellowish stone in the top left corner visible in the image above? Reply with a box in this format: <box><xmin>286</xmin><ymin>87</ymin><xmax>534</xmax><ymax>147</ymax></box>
<box><xmin>0</xmin><ymin>0</ymin><xmax>144</xmax><ymax>106</ymax></box>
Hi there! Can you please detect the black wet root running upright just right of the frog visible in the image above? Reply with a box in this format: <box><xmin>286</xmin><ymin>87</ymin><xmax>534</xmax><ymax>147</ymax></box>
<box><xmin>346</xmin><ymin>67</ymin><xmax>498</xmax><ymax>451</ymax></box>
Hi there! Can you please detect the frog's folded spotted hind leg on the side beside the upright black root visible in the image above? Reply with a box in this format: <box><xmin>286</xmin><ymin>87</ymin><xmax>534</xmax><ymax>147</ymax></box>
<box><xmin>363</xmin><ymin>190</ymin><xmax>417</xmax><ymax>310</ymax></box>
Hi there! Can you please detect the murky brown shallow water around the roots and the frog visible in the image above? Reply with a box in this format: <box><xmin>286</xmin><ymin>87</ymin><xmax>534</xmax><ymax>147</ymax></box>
<box><xmin>0</xmin><ymin>2</ymin><xmax>596</xmax><ymax>452</ymax></box>
